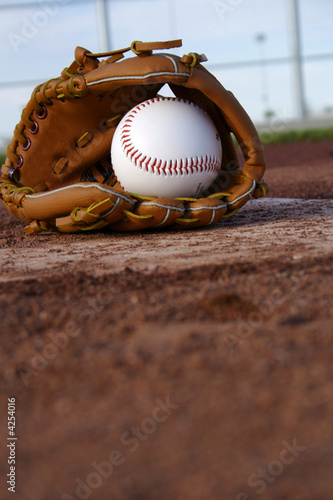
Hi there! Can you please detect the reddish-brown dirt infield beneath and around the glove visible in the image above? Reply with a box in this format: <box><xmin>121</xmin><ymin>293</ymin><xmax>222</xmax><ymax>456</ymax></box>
<box><xmin>0</xmin><ymin>141</ymin><xmax>333</xmax><ymax>500</ymax></box>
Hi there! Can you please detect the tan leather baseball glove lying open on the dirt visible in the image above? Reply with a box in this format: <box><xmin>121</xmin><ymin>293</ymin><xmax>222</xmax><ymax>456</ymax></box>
<box><xmin>0</xmin><ymin>40</ymin><xmax>267</xmax><ymax>234</ymax></box>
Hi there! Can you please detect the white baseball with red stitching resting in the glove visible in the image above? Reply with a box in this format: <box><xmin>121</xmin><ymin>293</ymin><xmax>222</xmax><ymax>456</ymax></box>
<box><xmin>111</xmin><ymin>97</ymin><xmax>222</xmax><ymax>198</ymax></box>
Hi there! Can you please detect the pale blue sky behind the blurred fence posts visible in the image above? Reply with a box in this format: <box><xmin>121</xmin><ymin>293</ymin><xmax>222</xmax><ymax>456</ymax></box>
<box><xmin>0</xmin><ymin>0</ymin><xmax>333</xmax><ymax>147</ymax></box>
